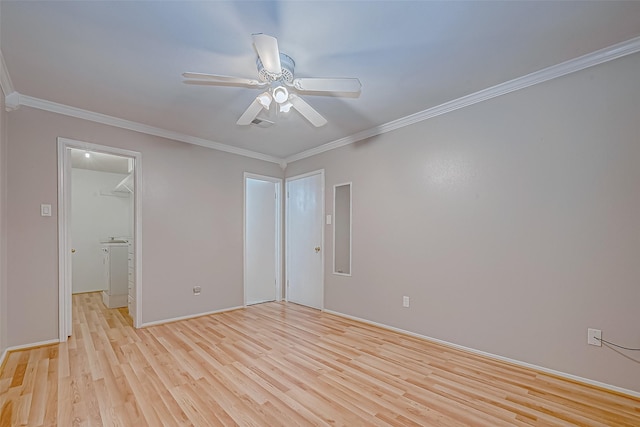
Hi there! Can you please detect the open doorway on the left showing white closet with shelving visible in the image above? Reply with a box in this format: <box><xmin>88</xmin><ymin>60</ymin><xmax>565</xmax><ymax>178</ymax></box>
<box><xmin>58</xmin><ymin>138</ymin><xmax>141</xmax><ymax>341</ymax></box>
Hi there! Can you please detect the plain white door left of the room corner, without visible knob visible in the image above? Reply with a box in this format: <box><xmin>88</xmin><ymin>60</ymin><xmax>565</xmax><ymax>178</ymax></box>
<box><xmin>244</xmin><ymin>177</ymin><xmax>282</xmax><ymax>305</ymax></box>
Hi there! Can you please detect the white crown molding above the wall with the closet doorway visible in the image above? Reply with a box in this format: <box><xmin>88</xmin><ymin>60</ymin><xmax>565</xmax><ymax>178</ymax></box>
<box><xmin>16</xmin><ymin>92</ymin><xmax>282</xmax><ymax>164</ymax></box>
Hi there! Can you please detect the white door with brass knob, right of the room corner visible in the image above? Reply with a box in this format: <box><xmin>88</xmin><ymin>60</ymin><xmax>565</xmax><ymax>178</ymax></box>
<box><xmin>287</xmin><ymin>171</ymin><xmax>324</xmax><ymax>309</ymax></box>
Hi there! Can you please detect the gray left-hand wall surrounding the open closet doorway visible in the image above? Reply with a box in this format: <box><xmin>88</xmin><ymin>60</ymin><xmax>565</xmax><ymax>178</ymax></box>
<box><xmin>7</xmin><ymin>107</ymin><xmax>283</xmax><ymax>346</ymax></box>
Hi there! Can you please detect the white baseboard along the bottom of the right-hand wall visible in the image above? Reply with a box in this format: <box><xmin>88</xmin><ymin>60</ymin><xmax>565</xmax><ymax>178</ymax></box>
<box><xmin>322</xmin><ymin>310</ymin><xmax>640</xmax><ymax>398</ymax></box>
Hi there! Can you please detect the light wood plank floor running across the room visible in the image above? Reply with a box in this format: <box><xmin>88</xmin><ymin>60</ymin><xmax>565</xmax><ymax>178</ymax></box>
<box><xmin>0</xmin><ymin>293</ymin><xmax>640</xmax><ymax>427</ymax></box>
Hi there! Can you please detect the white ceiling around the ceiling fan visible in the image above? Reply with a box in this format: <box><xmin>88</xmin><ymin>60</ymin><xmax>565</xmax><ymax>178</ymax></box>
<box><xmin>0</xmin><ymin>0</ymin><xmax>640</xmax><ymax>159</ymax></box>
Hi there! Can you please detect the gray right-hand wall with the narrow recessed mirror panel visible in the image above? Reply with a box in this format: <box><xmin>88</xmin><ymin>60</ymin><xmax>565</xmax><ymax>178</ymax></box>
<box><xmin>286</xmin><ymin>54</ymin><xmax>640</xmax><ymax>392</ymax></box>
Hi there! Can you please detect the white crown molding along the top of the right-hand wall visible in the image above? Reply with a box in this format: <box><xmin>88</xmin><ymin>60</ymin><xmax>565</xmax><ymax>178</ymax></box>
<box><xmin>285</xmin><ymin>37</ymin><xmax>640</xmax><ymax>163</ymax></box>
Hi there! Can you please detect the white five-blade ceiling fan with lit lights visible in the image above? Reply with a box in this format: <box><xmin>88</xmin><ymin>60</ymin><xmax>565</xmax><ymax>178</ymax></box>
<box><xmin>182</xmin><ymin>34</ymin><xmax>362</xmax><ymax>127</ymax></box>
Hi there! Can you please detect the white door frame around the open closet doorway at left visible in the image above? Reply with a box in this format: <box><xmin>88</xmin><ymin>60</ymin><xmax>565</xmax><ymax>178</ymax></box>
<box><xmin>58</xmin><ymin>137</ymin><xmax>142</xmax><ymax>342</ymax></box>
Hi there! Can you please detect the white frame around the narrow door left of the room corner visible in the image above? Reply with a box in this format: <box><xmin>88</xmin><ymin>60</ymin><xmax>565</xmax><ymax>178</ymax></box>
<box><xmin>242</xmin><ymin>172</ymin><xmax>282</xmax><ymax>308</ymax></box>
